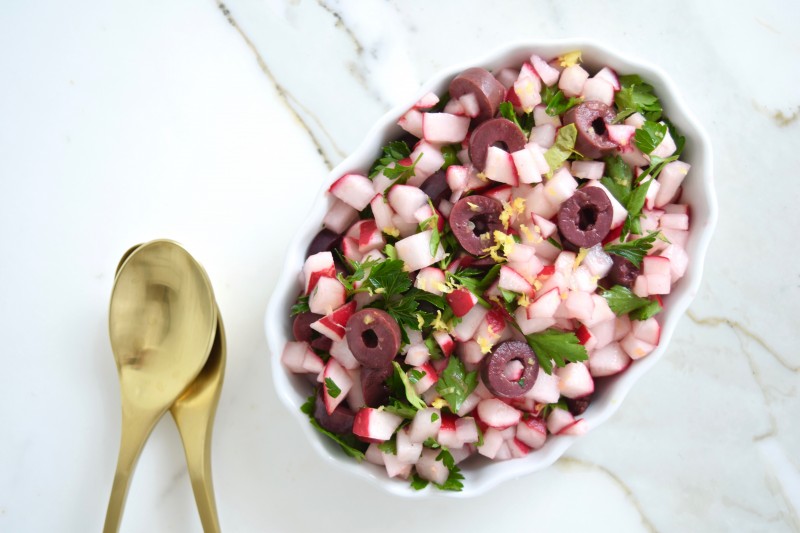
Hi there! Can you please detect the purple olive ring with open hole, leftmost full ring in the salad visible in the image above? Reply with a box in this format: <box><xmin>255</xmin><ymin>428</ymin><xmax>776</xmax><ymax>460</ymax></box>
<box><xmin>346</xmin><ymin>309</ymin><xmax>400</xmax><ymax>368</ymax></box>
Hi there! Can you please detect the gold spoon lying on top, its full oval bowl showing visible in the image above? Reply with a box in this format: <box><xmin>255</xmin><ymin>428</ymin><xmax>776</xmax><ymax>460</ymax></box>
<box><xmin>103</xmin><ymin>240</ymin><xmax>218</xmax><ymax>533</ymax></box>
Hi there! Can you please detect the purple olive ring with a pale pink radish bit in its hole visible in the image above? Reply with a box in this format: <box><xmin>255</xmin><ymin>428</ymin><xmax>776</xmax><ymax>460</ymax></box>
<box><xmin>481</xmin><ymin>341</ymin><xmax>539</xmax><ymax>398</ymax></box>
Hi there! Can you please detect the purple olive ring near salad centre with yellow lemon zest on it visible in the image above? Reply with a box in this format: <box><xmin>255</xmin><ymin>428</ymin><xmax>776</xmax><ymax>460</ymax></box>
<box><xmin>450</xmin><ymin>194</ymin><xmax>504</xmax><ymax>255</ymax></box>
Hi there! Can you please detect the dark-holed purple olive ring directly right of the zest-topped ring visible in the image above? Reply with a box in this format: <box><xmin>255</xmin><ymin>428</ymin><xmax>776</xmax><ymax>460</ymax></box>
<box><xmin>557</xmin><ymin>187</ymin><xmax>612</xmax><ymax>248</ymax></box>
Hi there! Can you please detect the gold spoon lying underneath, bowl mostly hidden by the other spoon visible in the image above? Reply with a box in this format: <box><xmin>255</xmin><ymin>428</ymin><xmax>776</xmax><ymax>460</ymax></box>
<box><xmin>112</xmin><ymin>245</ymin><xmax>227</xmax><ymax>532</ymax></box>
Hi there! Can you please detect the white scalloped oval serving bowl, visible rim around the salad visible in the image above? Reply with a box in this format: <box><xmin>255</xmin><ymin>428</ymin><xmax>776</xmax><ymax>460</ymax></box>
<box><xmin>266</xmin><ymin>40</ymin><xmax>717</xmax><ymax>498</ymax></box>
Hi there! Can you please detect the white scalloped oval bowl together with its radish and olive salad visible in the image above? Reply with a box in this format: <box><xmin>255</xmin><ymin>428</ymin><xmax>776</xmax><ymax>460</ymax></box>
<box><xmin>267</xmin><ymin>43</ymin><xmax>715</xmax><ymax>495</ymax></box>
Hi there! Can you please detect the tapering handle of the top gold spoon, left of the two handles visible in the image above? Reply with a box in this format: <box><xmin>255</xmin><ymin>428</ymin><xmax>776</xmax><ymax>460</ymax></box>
<box><xmin>103</xmin><ymin>407</ymin><xmax>164</xmax><ymax>533</ymax></box>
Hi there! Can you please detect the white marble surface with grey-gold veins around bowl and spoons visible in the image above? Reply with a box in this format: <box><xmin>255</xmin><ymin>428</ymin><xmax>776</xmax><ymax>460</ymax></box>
<box><xmin>0</xmin><ymin>0</ymin><xmax>800</xmax><ymax>532</ymax></box>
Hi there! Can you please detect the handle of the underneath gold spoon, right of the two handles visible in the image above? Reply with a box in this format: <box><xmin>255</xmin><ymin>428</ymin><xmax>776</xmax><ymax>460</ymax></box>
<box><xmin>170</xmin><ymin>404</ymin><xmax>220</xmax><ymax>533</ymax></box>
